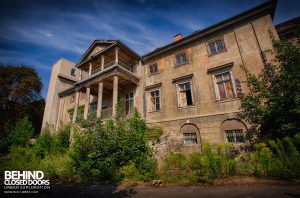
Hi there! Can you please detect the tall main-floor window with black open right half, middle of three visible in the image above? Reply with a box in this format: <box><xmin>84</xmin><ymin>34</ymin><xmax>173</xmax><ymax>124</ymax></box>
<box><xmin>178</xmin><ymin>82</ymin><xmax>193</xmax><ymax>107</ymax></box>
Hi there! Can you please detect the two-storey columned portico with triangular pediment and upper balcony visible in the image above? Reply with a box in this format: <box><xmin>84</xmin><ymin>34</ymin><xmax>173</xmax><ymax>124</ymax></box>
<box><xmin>61</xmin><ymin>40</ymin><xmax>139</xmax><ymax>123</ymax></box>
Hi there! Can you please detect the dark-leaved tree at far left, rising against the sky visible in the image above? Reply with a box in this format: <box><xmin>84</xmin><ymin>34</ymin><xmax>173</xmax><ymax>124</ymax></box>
<box><xmin>0</xmin><ymin>65</ymin><xmax>44</xmax><ymax>150</ymax></box>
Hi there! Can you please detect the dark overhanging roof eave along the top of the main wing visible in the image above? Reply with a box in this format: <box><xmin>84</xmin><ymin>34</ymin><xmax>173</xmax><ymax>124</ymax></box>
<box><xmin>142</xmin><ymin>0</ymin><xmax>277</xmax><ymax>60</ymax></box>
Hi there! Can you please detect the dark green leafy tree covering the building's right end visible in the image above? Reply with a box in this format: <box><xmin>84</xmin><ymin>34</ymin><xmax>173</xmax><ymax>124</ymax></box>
<box><xmin>240</xmin><ymin>35</ymin><xmax>300</xmax><ymax>138</ymax></box>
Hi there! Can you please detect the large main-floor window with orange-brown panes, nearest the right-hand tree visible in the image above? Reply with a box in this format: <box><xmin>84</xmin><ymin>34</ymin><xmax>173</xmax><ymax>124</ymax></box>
<box><xmin>214</xmin><ymin>71</ymin><xmax>236</xmax><ymax>100</ymax></box>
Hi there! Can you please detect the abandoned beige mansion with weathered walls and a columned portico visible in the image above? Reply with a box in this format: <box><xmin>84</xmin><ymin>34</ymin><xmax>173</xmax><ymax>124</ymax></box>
<box><xmin>43</xmin><ymin>1</ymin><xmax>290</xmax><ymax>152</ymax></box>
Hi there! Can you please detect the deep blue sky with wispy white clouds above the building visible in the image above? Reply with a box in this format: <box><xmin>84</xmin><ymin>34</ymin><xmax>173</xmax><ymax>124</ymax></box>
<box><xmin>0</xmin><ymin>0</ymin><xmax>300</xmax><ymax>97</ymax></box>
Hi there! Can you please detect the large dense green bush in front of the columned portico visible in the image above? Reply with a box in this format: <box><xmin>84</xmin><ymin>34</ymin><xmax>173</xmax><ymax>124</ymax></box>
<box><xmin>71</xmin><ymin>111</ymin><xmax>156</xmax><ymax>182</ymax></box>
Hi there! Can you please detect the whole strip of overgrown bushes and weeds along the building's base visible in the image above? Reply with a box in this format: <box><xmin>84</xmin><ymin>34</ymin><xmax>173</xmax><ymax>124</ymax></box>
<box><xmin>0</xmin><ymin>112</ymin><xmax>300</xmax><ymax>184</ymax></box>
